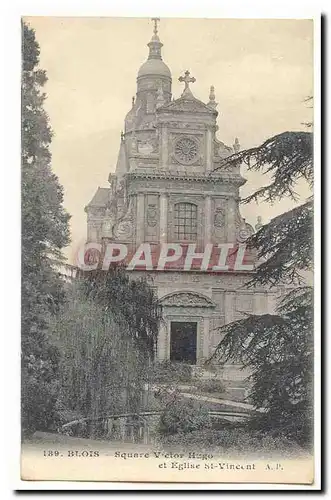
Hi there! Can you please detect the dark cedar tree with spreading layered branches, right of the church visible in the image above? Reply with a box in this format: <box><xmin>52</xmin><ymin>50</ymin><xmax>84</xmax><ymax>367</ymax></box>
<box><xmin>214</xmin><ymin>128</ymin><xmax>313</xmax><ymax>444</ymax></box>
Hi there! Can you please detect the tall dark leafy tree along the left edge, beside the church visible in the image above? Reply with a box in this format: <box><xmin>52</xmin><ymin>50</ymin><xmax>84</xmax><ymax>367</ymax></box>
<box><xmin>21</xmin><ymin>23</ymin><xmax>69</xmax><ymax>432</ymax></box>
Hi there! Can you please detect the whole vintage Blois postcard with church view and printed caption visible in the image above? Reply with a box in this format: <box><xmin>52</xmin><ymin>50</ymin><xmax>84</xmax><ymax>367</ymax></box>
<box><xmin>21</xmin><ymin>16</ymin><xmax>318</xmax><ymax>485</ymax></box>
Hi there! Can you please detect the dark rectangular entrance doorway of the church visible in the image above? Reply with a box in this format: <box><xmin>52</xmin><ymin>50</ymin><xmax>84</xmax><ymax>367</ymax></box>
<box><xmin>170</xmin><ymin>321</ymin><xmax>197</xmax><ymax>365</ymax></box>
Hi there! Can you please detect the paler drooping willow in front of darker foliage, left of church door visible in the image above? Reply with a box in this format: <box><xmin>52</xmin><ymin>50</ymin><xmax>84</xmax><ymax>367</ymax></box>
<box><xmin>52</xmin><ymin>283</ymin><xmax>145</xmax><ymax>436</ymax></box>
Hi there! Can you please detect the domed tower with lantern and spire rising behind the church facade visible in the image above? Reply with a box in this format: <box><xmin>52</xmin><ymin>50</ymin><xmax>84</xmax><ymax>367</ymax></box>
<box><xmin>125</xmin><ymin>18</ymin><xmax>171</xmax><ymax>133</ymax></box>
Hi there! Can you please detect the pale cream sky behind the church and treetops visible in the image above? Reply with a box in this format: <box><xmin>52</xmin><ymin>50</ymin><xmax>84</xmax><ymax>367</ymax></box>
<box><xmin>25</xmin><ymin>17</ymin><xmax>313</xmax><ymax>262</ymax></box>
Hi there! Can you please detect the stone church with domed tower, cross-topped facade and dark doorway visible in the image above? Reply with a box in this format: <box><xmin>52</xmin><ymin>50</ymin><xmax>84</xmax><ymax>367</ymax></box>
<box><xmin>85</xmin><ymin>19</ymin><xmax>279</xmax><ymax>365</ymax></box>
